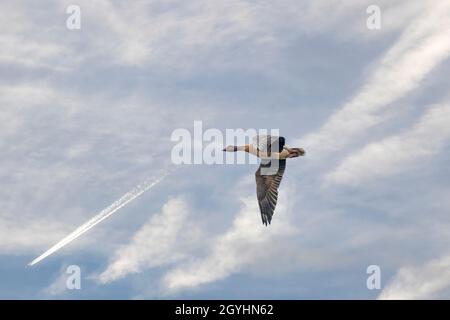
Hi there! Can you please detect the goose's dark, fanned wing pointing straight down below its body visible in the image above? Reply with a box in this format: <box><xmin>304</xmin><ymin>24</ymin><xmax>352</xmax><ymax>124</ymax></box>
<box><xmin>255</xmin><ymin>160</ymin><xmax>286</xmax><ymax>226</ymax></box>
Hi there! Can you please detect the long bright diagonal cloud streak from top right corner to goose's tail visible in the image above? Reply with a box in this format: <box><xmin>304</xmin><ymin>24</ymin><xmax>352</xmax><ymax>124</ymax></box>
<box><xmin>298</xmin><ymin>2</ymin><xmax>450</xmax><ymax>158</ymax></box>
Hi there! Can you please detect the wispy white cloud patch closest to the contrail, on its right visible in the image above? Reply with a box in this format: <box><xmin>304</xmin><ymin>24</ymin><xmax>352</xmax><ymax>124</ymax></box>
<box><xmin>99</xmin><ymin>198</ymin><xmax>199</xmax><ymax>283</ymax></box>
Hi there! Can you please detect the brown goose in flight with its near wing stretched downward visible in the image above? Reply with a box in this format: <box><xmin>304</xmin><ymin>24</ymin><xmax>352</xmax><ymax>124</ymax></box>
<box><xmin>223</xmin><ymin>135</ymin><xmax>305</xmax><ymax>226</ymax></box>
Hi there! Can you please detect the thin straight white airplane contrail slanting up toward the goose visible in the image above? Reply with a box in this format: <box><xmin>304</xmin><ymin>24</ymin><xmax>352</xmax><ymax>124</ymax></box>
<box><xmin>28</xmin><ymin>171</ymin><xmax>170</xmax><ymax>266</ymax></box>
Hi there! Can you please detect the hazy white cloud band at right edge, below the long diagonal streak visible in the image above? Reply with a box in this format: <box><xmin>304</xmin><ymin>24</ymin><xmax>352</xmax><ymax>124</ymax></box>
<box><xmin>325</xmin><ymin>105</ymin><xmax>450</xmax><ymax>184</ymax></box>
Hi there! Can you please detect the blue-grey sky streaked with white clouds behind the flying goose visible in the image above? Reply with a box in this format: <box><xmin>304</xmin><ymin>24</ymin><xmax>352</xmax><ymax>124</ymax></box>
<box><xmin>0</xmin><ymin>0</ymin><xmax>450</xmax><ymax>299</ymax></box>
